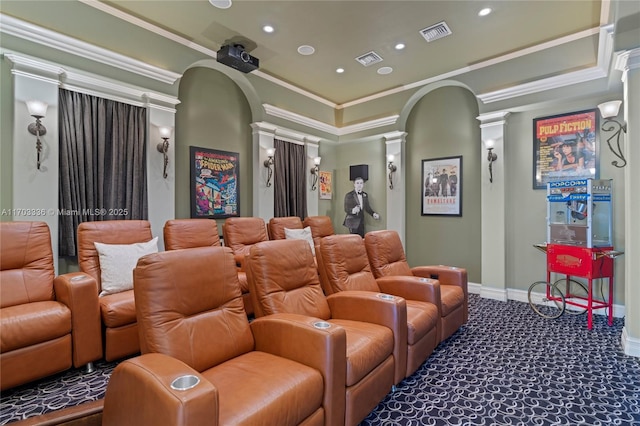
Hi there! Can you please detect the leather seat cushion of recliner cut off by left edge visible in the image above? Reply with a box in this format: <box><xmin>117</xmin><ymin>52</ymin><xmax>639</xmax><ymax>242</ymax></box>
<box><xmin>0</xmin><ymin>301</ymin><xmax>71</xmax><ymax>353</ymax></box>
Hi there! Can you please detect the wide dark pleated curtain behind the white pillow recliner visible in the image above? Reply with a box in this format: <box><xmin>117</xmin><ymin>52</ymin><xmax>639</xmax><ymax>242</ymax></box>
<box><xmin>58</xmin><ymin>89</ymin><xmax>147</xmax><ymax>256</ymax></box>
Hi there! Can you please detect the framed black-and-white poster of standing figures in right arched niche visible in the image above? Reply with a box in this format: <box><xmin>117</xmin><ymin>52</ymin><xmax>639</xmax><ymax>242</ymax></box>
<box><xmin>421</xmin><ymin>155</ymin><xmax>462</xmax><ymax>216</ymax></box>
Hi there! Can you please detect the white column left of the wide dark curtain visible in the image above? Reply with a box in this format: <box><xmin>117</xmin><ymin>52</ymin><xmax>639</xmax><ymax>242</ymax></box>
<box><xmin>5</xmin><ymin>54</ymin><xmax>64</xmax><ymax>273</ymax></box>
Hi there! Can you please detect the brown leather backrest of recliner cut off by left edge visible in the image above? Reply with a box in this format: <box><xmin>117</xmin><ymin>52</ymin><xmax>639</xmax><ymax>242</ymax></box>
<box><xmin>0</xmin><ymin>222</ymin><xmax>55</xmax><ymax>308</ymax></box>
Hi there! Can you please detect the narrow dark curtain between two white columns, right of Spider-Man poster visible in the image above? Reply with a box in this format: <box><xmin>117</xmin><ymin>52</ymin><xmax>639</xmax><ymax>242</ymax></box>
<box><xmin>273</xmin><ymin>139</ymin><xmax>307</xmax><ymax>219</ymax></box>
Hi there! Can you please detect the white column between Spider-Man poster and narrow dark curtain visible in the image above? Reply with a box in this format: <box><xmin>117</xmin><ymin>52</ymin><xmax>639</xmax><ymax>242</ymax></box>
<box><xmin>251</xmin><ymin>122</ymin><xmax>278</xmax><ymax>222</ymax></box>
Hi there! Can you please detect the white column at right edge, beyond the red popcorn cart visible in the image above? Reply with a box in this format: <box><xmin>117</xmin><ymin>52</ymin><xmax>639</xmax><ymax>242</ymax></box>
<box><xmin>616</xmin><ymin>48</ymin><xmax>640</xmax><ymax>357</ymax></box>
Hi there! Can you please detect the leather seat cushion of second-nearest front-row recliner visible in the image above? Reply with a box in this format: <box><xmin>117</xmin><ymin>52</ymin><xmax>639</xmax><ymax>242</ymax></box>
<box><xmin>329</xmin><ymin>319</ymin><xmax>393</xmax><ymax>386</ymax></box>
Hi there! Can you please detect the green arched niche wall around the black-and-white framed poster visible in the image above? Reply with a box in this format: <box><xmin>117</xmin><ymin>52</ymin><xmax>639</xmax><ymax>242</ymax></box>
<box><xmin>405</xmin><ymin>87</ymin><xmax>484</xmax><ymax>282</ymax></box>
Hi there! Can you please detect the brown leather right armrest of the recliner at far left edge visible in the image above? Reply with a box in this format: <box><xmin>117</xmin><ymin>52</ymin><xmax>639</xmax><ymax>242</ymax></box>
<box><xmin>53</xmin><ymin>272</ymin><xmax>102</xmax><ymax>368</ymax></box>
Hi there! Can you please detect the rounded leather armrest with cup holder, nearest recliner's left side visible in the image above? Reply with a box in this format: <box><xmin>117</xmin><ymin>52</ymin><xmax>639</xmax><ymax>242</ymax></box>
<box><xmin>102</xmin><ymin>353</ymin><xmax>219</xmax><ymax>426</ymax></box>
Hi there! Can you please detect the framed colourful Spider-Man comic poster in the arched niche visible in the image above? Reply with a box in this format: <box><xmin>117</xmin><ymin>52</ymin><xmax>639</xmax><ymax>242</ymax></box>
<box><xmin>189</xmin><ymin>146</ymin><xmax>240</xmax><ymax>219</ymax></box>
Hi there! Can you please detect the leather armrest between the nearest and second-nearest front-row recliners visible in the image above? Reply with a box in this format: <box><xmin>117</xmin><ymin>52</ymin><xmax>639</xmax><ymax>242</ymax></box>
<box><xmin>251</xmin><ymin>313</ymin><xmax>347</xmax><ymax>425</ymax></box>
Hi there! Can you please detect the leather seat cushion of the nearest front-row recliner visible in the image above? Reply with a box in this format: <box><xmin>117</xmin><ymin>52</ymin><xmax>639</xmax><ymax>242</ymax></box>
<box><xmin>202</xmin><ymin>351</ymin><xmax>324</xmax><ymax>425</ymax></box>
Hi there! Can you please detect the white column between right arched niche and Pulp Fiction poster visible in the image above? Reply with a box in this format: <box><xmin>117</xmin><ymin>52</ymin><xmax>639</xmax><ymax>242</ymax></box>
<box><xmin>478</xmin><ymin>111</ymin><xmax>509</xmax><ymax>301</ymax></box>
